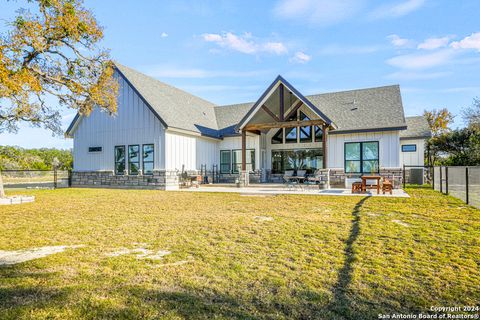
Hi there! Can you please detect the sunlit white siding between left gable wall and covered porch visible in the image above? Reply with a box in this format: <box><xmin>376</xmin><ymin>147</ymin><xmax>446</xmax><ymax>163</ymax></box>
<box><xmin>165</xmin><ymin>130</ymin><xmax>219</xmax><ymax>171</ymax></box>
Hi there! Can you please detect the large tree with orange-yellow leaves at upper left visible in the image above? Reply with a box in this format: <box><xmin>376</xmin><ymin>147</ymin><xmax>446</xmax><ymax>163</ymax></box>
<box><xmin>0</xmin><ymin>0</ymin><xmax>118</xmax><ymax>196</ymax></box>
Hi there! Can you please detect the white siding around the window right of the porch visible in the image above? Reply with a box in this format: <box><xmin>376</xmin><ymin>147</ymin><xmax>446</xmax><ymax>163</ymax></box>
<box><xmin>327</xmin><ymin>131</ymin><xmax>401</xmax><ymax>169</ymax></box>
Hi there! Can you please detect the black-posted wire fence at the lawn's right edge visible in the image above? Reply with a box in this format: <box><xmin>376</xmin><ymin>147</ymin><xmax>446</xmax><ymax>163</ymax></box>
<box><xmin>433</xmin><ymin>166</ymin><xmax>480</xmax><ymax>208</ymax></box>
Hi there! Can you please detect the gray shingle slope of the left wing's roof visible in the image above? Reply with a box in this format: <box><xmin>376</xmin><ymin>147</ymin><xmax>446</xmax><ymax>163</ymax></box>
<box><xmin>115</xmin><ymin>63</ymin><xmax>218</xmax><ymax>135</ymax></box>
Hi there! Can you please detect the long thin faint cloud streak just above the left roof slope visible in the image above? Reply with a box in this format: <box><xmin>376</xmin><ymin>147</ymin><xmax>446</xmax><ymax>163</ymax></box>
<box><xmin>139</xmin><ymin>65</ymin><xmax>271</xmax><ymax>79</ymax></box>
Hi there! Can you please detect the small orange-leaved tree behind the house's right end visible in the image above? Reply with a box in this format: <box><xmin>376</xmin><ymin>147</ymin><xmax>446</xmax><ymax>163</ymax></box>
<box><xmin>423</xmin><ymin>108</ymin><xmax>453</xmax><ymax>166</ymax></box>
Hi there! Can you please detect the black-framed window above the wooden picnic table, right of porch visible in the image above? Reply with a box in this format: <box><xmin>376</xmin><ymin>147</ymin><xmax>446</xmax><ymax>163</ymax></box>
<box><xmin>344</xmin><ymin>141</ymin><xmax>380</xmax><ymax>173</ymax></box>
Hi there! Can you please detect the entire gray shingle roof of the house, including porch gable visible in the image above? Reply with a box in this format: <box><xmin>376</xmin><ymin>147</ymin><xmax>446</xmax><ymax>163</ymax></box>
<box><xmin>66</xmin><ymin>63</ymin><xmax>406</xmax><ymax>138</ymax></box>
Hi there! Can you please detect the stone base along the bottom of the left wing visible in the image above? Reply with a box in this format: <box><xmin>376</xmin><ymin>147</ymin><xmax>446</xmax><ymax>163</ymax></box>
<box><xmin>72</xmin><ymin>170</ymin><xmax>179</xmax><ymax>190</ymax></box>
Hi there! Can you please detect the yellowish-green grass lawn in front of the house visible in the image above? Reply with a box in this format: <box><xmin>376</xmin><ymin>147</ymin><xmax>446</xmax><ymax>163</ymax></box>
<box><xmin>0</xmin><ymin>188</ymin><xmax>480</xmax><ymax>319</ymax></box>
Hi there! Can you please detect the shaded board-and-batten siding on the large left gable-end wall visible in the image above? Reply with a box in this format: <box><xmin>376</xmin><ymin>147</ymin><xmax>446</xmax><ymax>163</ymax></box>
<box><xmin>73</xmin><ymin>77</ymin><xmax>164</xmax><ymax>171</ymax></box>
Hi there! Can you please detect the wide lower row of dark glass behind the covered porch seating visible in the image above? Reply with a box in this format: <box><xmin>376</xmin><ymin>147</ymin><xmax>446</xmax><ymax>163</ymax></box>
<box><xmin>272</xmin><ymin>149</ymin><xmax>323</xmax><ymax>173</ymax></box>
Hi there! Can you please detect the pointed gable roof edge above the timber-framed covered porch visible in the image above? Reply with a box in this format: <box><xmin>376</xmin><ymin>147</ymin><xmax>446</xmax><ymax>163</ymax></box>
<box><xmin>236</xmin><ymin>75</ymin><xmax>336</xmax><ymax>130</ymax></box>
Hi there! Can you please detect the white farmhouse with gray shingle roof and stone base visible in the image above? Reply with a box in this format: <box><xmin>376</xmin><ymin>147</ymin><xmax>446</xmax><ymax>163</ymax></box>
<box><xmin>66</xmin><ymin>64</ymin><xmax>429</xmax><ymax>189</ymax></box>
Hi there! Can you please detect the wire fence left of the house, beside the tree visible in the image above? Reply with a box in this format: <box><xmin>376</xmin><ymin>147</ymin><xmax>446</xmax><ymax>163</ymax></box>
<box><xmin>1</xmin><ymin>170</ymin><xmax>71</xmax><ymax>189</ymax></box>
